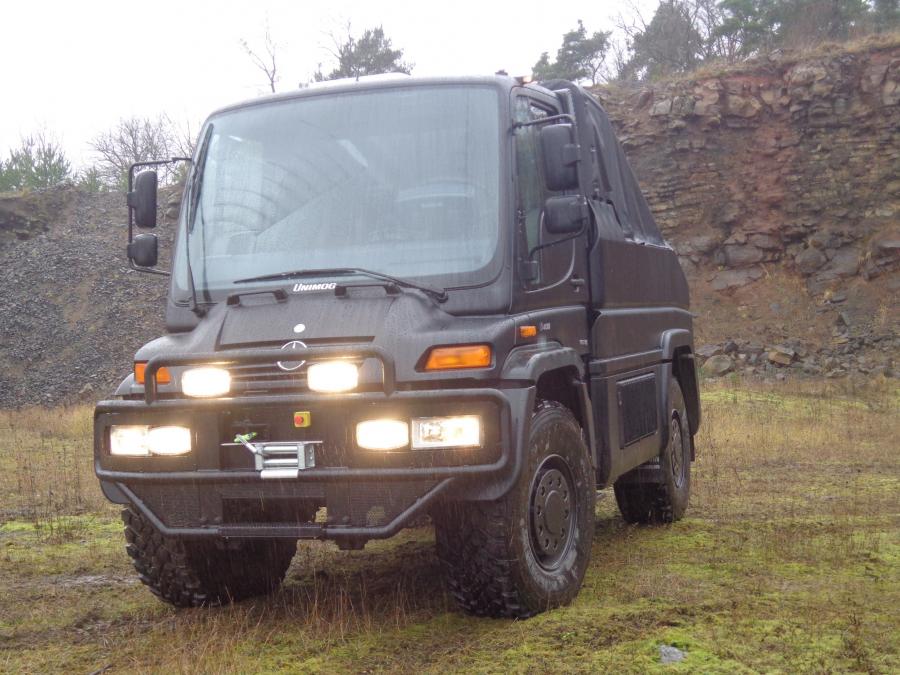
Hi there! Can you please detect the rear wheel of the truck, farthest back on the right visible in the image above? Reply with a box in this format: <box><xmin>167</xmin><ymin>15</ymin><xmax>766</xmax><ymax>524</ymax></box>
<box><xmin>613</xmin><ymin>378</ymin><xmax>693</xmax><ymax>524</ymax></box>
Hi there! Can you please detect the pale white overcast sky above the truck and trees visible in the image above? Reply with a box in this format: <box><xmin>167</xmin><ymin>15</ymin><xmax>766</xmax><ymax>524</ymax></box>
<box><xmin>0</xmin><ymin>0</ymin><xmax>656</xmax><ymax>165</ymax></box>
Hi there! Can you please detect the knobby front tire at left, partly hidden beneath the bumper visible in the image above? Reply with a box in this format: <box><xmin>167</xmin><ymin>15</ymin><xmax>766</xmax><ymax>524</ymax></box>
<box><xmin>122</xmin><ymin>507</ymin><xmax>297</xmax><ymax>607</ymax></box>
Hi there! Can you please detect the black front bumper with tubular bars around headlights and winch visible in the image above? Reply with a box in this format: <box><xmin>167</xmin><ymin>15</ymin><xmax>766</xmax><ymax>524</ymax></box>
<box><xmin>94</xmin><ymin>388</ymin><xmax>533</xmax><ymax>545</ymax></box>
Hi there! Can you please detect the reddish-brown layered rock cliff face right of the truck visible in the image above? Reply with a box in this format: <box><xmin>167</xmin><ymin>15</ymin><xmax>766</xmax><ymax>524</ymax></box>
<box><xmin>597</xmin><ymin>40</ymin><xmax>900</xmax><ymax>375</ymax></box>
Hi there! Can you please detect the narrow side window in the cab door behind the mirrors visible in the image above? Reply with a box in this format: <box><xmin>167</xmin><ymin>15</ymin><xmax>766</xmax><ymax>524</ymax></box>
<box><xmin>514</xmin><ymin>96</ymin><xmax>554</xmax><ymax>287</ymax></box>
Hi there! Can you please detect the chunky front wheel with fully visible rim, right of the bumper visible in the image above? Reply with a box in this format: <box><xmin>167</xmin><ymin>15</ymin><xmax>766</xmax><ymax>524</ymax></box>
<box><xmin>434</xmin><ymin>401</ymin><xmax>596</xmax><ymax>618</ymax></box>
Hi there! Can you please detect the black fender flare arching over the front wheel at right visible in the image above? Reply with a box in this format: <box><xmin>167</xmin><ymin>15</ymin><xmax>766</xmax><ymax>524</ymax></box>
<box><xmin>500</xmin><ymin>343</ymin><xmax>600</xmax><ymax>468</ymax></box>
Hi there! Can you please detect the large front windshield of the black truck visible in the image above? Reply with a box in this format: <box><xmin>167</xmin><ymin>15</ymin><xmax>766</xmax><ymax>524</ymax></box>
<box><xmin>176</xmin><ymin>86</ymin><xmax>500</xmax><ymax>292</ymax></box>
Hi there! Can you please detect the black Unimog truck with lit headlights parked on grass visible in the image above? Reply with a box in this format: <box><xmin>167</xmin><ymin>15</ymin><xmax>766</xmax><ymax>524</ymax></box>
<box><xmin>94</xmin><ymin>76</ymin><xmax>700</xmax><ymax>617</ymax></box>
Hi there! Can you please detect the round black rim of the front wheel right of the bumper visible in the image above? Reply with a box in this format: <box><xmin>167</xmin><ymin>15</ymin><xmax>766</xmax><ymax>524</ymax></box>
<box><xmin>529</xmin><ymin>455</ymin><xmax>577</xmax><ymax>570</ymax></box>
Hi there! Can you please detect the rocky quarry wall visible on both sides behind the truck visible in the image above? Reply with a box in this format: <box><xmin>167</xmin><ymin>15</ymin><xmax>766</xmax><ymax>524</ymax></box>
<box><xmin>0</xmin><ymin>40</ymin><xmax>900</xmax><ymax>408</ymax></box>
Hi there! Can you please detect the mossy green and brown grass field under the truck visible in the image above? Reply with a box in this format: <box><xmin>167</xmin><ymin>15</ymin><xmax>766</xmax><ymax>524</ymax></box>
<box><xmin>0</xmin><ymin>381</ymin><xmax>900</xmax><ymax>673</ymax></box>
